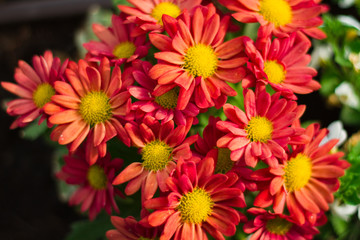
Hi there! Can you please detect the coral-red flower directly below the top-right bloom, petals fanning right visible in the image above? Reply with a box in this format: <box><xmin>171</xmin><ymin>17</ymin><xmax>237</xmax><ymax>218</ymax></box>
<box><xmin>242</xmin><ymin>33</ymin><xmax>320</xmax><ymax>100</ymax></box>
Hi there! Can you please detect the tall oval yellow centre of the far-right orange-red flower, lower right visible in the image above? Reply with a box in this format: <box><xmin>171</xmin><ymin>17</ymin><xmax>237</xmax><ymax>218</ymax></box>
<box><xmin>284</xmin><ymin>153</ymin><xmax>312</xmax><ymax>192</ymax></box>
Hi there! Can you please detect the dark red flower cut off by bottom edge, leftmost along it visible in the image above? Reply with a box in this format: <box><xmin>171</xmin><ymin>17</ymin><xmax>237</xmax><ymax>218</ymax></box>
<box><xmin>106</xmin><ymin>216</ymin><xmax>160</xmax><ymax>240</ymax></box>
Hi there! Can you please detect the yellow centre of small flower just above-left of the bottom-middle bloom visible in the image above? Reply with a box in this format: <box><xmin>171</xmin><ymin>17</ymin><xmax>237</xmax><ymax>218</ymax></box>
<box><xmin>141</xmin><ymin>140</ymin><xmax>173</xmax><ymax>171</ymax></box>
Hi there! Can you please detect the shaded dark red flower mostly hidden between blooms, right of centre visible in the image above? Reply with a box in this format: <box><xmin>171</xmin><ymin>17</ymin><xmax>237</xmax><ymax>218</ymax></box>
<box><xmin>193</xmin><ymin>116</ymin><xmax>256</xmax><ymax>191</ymax></box>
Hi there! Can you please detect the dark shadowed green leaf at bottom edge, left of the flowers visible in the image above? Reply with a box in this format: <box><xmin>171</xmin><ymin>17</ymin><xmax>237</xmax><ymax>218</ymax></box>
<box><xmin>66</xmin><ymin>213</ymin><xmax>114</xmax><ymax>240</ymax></box>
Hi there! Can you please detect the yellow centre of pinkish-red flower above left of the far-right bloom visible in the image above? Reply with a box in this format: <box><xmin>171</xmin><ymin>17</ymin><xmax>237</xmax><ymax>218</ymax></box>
<box><xmin>245</xmin><ymin>116</ymin><xmax>273</xmax><ymax>143</ymax></box>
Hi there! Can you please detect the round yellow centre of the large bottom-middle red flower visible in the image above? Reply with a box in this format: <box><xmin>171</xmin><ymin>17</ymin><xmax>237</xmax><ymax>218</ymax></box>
<box><xmin>177</xmin><ymin>187</ymin><xmax>214</xmax><ymax>224</ymax></box>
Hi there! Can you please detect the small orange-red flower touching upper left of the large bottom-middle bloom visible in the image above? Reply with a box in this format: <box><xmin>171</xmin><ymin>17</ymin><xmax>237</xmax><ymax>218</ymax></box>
<box><xmin>113</xmin><ymin>116</ymin><xmax>197</xmax><ymax>200</ymax></box>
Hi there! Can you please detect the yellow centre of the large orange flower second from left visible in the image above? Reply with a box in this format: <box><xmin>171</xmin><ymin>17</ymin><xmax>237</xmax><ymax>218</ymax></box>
<box><xmin>79</xmin><ymin>91</ymin><xmax>112</xmax><ymax>126</ymax></box>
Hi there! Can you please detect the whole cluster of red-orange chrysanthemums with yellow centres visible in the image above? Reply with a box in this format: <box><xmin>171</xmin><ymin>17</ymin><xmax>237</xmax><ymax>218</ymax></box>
<box><xmin>1</xmin><ymin>0</ymin><xmax>349</xmax><ymax>240</ymax></box>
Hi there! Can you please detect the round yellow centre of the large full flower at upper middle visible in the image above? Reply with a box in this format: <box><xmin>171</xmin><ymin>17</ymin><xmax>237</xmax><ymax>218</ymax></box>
<box><xmin>183</xmin><ymin>43</ymin><xmax>218</xmax><ymax>78</ymax></box>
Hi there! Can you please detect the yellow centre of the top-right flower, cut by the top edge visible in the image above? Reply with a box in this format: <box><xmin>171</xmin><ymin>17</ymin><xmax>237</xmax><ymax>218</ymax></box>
<box><xmin>259</xmin><ymin>0</ymin><xmax>292</xmax><ymax>27</ymax></box>
